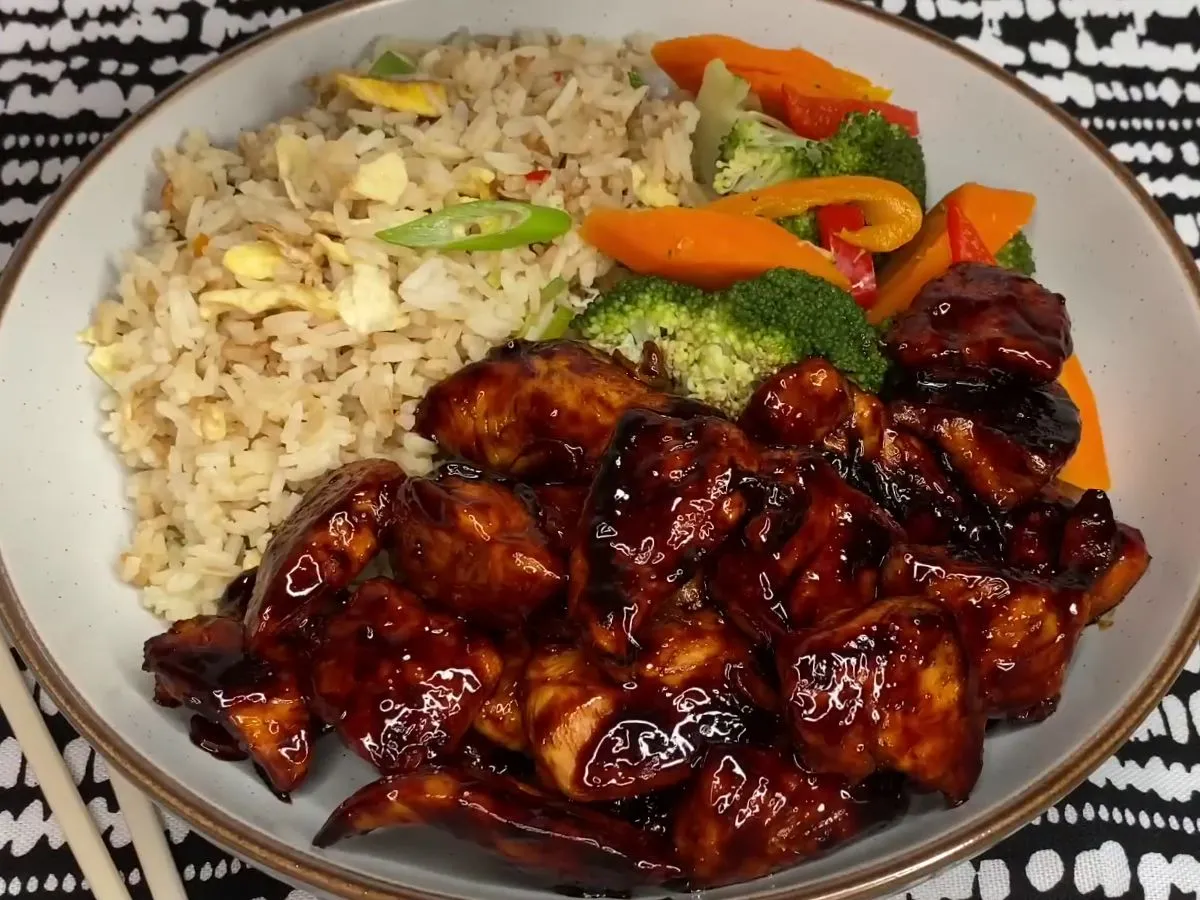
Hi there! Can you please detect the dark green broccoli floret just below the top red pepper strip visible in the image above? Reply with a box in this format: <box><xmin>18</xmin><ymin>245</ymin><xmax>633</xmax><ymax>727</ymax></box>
<box><xmin>817</xmin><ymin>112</ymin><xmax>925</xmax><ymax>209</ymax></box>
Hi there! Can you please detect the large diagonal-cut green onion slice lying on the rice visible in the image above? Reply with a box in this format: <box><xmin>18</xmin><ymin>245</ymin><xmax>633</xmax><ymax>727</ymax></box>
<box><xmin>376</xmin><ymin>200</ymin><xmax>571</xmax><ymax>250</ymax></box>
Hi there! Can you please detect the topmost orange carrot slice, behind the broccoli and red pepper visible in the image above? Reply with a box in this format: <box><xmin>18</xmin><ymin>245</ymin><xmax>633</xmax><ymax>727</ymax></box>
<box><xmin>650</xmin><ymin>35</ymin><xmax>892</xmax><ymax>118</ymax></box>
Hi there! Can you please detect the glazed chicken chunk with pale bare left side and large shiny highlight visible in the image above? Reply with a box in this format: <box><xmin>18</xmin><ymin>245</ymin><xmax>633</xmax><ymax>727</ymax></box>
<box><xmin>524</xmin><ymin>605</ymin><xmax>776</xmax><ymax>800</ymax></box>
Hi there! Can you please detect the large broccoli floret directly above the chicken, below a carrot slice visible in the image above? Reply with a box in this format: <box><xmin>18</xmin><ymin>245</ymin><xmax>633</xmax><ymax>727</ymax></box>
<box><xmin>574</xmin><ymin>269</ymin><xmax>888</xmax><ymax>414</ymax></box>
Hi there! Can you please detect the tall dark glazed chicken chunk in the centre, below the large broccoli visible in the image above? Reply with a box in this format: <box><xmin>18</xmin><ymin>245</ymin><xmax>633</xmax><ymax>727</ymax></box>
<box><xmin>569</xmin><ymin>410</ymin><xmax>757</xmax><ymax>659</ymax></box>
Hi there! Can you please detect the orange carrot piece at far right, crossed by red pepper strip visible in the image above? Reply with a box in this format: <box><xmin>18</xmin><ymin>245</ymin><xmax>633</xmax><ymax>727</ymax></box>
<box><xmin>868</xmin><ymin>184</ymin><xmax>1037</xmax><ymax>325</ymax></box>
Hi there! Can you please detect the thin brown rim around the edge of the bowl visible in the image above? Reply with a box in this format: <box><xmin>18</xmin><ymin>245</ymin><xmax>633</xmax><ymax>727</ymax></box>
<box><xmin>0</xmin><ymin>0</ymin><xmax>1200</xmax><ymax>900</ymax></box>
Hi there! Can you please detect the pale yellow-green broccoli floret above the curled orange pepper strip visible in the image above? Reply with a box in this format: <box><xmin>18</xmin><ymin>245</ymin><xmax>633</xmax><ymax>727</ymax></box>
<box><xmin>713</xmin><ymin>120</ymin><xmax>818</xmax><ymax>194</ymax></box>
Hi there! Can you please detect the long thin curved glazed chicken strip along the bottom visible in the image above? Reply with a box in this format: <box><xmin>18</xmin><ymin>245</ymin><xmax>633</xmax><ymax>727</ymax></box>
<box><xmin>313</xmin><ymin>767</ymin><xmax>679</xmax><ymax>892</ymax></box>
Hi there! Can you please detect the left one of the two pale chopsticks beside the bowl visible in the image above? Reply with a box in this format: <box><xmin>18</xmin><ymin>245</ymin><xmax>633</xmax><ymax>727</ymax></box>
<box><xmin>0</xmin><ymin>641</ymin><xmax>131</xmax><ymax>900</ymax></box>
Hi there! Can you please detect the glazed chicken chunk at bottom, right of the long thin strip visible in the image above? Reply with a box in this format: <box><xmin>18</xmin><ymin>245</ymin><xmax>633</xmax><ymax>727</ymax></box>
<box><xmin>672</xmin><ymin>746</ymin><xmax>907</xmax><ymax>889</ymax></box>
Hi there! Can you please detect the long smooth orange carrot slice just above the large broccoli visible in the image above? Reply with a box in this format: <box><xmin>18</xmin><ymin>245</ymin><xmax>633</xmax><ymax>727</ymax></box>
<box><xmin>580</xmin><ymin>206</ymin><xmax>850</xmax><ymax>290</ymax></box>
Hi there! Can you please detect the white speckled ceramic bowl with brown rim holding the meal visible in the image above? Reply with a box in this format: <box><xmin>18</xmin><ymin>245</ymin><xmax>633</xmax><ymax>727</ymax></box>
<box><xmin>0</xmin><ymin>0</ymin><xmax>1200</xmax><ymax>900</ymax></box>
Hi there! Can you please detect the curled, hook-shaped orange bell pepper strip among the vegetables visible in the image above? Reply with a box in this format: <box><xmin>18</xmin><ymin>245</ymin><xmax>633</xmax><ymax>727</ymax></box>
<box><xmin>704</xmin><ymin>175</ymin><xmax>922</xmax><ymax>253</ymax></box>
